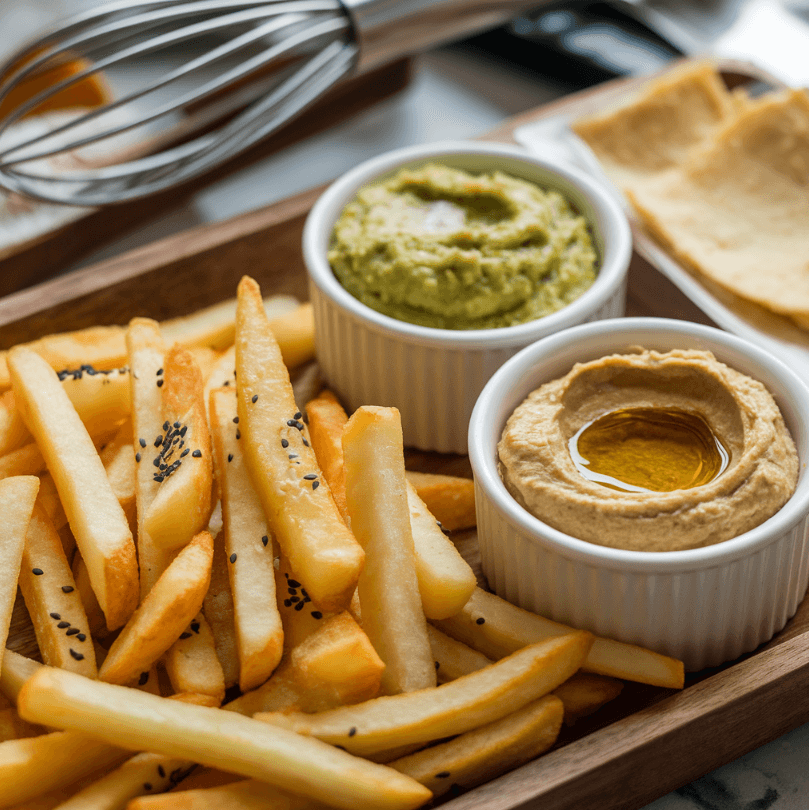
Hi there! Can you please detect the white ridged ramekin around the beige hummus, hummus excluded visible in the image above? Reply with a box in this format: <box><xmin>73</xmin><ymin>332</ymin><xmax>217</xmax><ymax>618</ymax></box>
<box><xmin>469</xmin><ymin>318</ymin><xmax>809</xmax><ymax>671</ymax></box>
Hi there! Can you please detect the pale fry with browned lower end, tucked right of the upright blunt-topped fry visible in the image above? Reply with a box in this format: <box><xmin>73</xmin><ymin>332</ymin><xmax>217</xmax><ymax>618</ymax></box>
<box><xmin>407</xmin><ymin>482</ymin><xmax>477</xmax><ymax>619</ymax></box>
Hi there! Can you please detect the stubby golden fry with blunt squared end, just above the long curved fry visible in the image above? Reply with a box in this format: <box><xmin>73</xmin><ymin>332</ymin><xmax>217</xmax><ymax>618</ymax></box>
<box><xmin>225</xmin><ymin>612</ymin><xmax>385</xmax><ymax>715</ymax></box>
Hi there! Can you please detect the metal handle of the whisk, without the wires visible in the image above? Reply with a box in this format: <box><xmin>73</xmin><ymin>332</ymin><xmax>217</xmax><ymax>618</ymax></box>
<box><xmin>341</xmin><ymin>0</ymin><xmax>548</xmax><ymax>72</ymax></box>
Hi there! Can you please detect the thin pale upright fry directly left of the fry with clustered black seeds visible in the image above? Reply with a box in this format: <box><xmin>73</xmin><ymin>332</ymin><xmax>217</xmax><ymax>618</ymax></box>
<box><xmin>125</xmin><ymin>318</ymin><xmax>174</xmax><ymax>599</ymax></box>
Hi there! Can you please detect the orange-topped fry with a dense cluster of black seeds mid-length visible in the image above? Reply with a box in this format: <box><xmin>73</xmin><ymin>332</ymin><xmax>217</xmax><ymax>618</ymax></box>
<box><xmin>143</xmin><ymin>346</ymin><xmax>213</xmax><ymax>549</ymax></box>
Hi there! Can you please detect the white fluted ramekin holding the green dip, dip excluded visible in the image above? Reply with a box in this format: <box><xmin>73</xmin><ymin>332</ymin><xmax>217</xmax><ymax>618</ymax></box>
<box><xmin>303</xmin><ymin>141</ymin><xmax>632</xmax><ymax>453</ymax></box>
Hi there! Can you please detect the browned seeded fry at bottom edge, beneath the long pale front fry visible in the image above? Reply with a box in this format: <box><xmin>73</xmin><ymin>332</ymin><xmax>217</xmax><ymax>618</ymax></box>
<box><xmin>52</xmin><ymin>753</ymin><xmax>193</xmax><ymax>810</ymax></box>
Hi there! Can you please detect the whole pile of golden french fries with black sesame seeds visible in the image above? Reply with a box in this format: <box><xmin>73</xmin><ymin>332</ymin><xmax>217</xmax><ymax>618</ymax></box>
<box><xmin>0</xmin><ymin>277</ymin><xmax>683</xmax><ymax>810</ymax></box>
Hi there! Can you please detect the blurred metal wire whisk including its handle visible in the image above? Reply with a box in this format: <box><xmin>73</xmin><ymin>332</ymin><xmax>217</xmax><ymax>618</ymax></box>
<box><xmin>0</xmin><ymin>0</ymin><xmax>539</xmax><ymax>206</ymax></box>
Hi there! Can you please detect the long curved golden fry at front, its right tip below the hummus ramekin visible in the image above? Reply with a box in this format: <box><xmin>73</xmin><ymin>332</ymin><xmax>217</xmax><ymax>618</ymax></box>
<box><xmin>258</xmin><ymin>632</ymin><xmax>593</xmax><ymax>755</ymax></box>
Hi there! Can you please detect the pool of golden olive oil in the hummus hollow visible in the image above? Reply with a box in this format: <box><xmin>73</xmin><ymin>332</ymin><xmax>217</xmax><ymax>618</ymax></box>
<box><xmin>568</xmin><ymin>408</ymin><xmax>730</xmax><ymax>492</ymax></box>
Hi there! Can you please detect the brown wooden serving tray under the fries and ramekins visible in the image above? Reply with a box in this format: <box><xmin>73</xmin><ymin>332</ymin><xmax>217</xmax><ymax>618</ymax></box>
<box><xmin>0</xmin><ymin>61</ymin><xmax>809</xmax><ymax>810</ymax></box>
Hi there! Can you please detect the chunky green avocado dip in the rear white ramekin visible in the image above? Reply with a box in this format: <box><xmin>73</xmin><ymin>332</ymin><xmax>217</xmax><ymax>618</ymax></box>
<box><xmin>329</xmin><ymin>165</ymin><xmax>597</xmax><ymax>329</ymax></box>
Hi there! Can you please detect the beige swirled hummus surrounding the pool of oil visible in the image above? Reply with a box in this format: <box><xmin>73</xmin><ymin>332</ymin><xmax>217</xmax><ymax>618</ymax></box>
<box><xmin>498</xmin><ymin>349</ymin><xmax>798</xmax><ymax>551</ymax></box>
